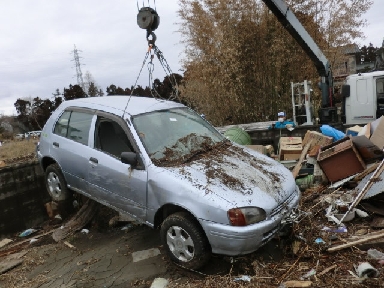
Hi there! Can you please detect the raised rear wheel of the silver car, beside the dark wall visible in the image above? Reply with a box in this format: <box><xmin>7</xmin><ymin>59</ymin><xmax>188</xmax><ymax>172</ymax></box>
<box><xmin>45</xmin><ymin>164</ymin><xmax>71</xmax><ymax>202</ymax></box>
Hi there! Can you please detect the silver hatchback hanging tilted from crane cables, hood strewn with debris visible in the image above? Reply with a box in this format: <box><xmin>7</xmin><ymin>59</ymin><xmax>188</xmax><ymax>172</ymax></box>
<box><xmin>38</xmin><ymin>96</ymin><xmax>300</xmax><ymax>269</ymax></box>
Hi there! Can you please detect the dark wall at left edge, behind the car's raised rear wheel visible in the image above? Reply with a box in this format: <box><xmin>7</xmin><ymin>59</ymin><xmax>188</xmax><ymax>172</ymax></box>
<box><xmin>0</xmin><ymin>161</ymin><xmax>50</xmax><ymax>239</ymax></box>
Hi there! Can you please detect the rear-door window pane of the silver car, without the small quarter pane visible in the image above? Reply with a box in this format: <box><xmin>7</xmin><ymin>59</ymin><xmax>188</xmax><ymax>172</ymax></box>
<box><xmin>67</xmin><ymin>111</ymin><xmax>93</xmax><ymax>145</ymax></box>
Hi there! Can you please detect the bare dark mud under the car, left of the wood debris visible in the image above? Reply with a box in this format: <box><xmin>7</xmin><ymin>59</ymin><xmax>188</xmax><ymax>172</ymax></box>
<box><xmin>0</xmin><ymin>207</ymin><xmax>256</xmax><ymax>288</ymax></box>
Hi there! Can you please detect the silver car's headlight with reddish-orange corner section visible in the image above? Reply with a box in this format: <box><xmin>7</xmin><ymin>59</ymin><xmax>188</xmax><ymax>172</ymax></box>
<box><xmin>228</xmin><ymin>207</ymin><xmax>267</xmax><ymax>226</ymax></box>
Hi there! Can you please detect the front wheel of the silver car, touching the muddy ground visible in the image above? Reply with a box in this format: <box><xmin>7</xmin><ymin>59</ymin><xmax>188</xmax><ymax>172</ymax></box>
<box><xmin>160</xmin><ymin>212</ymin><xmax>212</xmax><ymax>270</ymax></box>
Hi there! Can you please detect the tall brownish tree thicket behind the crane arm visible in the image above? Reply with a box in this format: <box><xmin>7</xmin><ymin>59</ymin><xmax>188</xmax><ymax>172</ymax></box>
<box><xmin>178</xmin><ymin>0</ymin><xmax>372</xmax><ymax>125</ymax></box>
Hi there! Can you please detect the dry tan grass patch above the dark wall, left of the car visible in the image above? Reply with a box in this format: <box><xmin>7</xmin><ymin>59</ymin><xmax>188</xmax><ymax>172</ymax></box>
<box><xmin>0</xmin><ymin>140</ymin><xmax>38</xmax><ymax>164</ymax></box>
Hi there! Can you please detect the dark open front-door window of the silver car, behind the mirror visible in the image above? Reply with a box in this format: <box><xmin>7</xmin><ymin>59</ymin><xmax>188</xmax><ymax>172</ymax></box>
<box><xmin>95</xmin><ymin>116</ymin><xmax>133</xmax><ymax>158</ymax></box>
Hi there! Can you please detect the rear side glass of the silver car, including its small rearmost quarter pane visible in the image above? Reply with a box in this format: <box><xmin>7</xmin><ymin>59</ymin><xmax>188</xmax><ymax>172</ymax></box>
<box><xmin>54</xmin><ymin>111</ymin><xmax>93</xmax><ymax>145</ymax></box>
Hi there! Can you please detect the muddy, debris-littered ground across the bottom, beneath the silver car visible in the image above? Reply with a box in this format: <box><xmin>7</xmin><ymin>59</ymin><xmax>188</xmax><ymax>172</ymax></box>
<box><xmin>0</xmin><ymin>187</ymin><xmax>384</xmax><ymax>288</ymax></box>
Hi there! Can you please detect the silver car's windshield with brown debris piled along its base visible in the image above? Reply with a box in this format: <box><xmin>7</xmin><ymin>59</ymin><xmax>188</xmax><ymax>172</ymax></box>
<box><xmin>133</xmin><ymin>108</ymin><xmax>226</xmax><ymax>166</ymax></box>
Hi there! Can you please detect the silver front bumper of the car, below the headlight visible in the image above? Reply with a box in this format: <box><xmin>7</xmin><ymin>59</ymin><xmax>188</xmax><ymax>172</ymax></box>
<box><xmin>200</xmin><ymin>188</ymin><xmax>301</xmax><ymax>256</ymax></box>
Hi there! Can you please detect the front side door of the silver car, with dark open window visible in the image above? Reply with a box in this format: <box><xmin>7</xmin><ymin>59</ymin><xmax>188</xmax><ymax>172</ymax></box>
<box><xmin>88</xmin><ymin>112</ymin><xmax>147</xmax><ymax>221</ymax></box>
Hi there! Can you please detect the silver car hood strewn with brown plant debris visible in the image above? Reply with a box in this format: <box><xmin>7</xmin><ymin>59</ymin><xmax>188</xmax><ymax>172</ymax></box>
<box><xmin>164</xmin><ymin>143</ymin><xmax>296</xmax><ymax>210</ymax></box>
